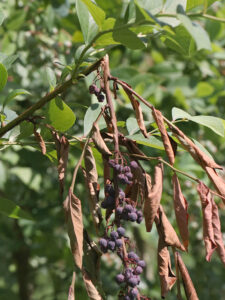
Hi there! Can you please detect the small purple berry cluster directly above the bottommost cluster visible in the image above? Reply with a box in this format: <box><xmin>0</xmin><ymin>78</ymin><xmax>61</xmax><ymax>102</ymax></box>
<box><xmin>99</xmin><ymin>227</ymin><xmax>125</xmax><ymax>253</ymax></box>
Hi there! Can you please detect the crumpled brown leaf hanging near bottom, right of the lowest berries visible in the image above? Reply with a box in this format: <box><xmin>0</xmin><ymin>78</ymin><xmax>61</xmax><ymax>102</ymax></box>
<box><xmin>158</xmin><ymin>235</ymin><xmax>176</xmax><ymax>298</ymax></box>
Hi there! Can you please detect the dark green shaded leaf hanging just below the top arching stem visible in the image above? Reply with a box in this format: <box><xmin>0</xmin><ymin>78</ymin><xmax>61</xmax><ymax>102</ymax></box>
<box><xmin>113</xmin><ymin>29</ymin><xmax>145</xmax><ymax>50</ymax></box>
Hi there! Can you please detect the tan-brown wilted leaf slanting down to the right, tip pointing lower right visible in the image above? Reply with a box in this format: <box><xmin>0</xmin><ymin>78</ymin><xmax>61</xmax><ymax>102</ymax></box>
<box><xmin>155</xmin><ymin>205</ymin><xmax>185</xmax><ymax>251</ymax></box>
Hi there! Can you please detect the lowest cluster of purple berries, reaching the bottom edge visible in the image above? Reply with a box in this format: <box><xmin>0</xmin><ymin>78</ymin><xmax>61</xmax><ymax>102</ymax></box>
<box><xmin>116</xmin><ymin>251</ymin><xmax>146</xmax><ymax>300</ymax></box>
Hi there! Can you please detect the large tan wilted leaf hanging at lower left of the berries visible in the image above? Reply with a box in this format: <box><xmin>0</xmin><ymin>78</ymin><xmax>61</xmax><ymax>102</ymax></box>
<box><xmin>63</xmin><ymin>190</ymin><xmax>83</xmax><ymax>269</ymax></box>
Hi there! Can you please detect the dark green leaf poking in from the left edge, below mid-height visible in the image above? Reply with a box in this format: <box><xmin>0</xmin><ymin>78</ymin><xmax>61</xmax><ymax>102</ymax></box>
<box><xmin>0</xmin><ymin>197</ymin><xmax>33</xmax><ymax>220</ymax></box>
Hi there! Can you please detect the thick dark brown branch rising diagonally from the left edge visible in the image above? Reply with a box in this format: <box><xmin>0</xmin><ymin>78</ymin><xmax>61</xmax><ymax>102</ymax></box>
<box><xmin>0</xmin><ymin>59</ymin><xmax>102</xmax><ymax>138</ymax></box>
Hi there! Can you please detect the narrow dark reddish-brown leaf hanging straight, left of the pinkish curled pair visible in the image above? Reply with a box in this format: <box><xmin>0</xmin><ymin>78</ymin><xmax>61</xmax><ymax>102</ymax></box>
<box><xmin>173</xmin><ymin>174</ymin><xmax>189</xmax><ymax>250</ymax></box>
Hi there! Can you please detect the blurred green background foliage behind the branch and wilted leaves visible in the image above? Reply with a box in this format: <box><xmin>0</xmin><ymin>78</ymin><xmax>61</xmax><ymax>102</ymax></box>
<box><xmin>0</xmin><ymin>0</ymin><xmax>225</xmax><ymax>300</ymax></box>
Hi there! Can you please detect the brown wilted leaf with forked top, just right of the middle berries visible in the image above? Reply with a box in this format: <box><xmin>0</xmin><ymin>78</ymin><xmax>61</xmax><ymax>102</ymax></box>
<box><xmin>144</xmin><ymin>163</ymin><xmax>163</xmax><ymax>232</ymax></box>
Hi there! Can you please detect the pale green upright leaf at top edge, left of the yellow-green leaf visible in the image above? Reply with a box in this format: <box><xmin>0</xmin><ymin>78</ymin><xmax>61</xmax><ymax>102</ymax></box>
<box><xmin>76</xmin><ymin>0</ymin><xmax>98</xmax><ymax>44</ymax></box>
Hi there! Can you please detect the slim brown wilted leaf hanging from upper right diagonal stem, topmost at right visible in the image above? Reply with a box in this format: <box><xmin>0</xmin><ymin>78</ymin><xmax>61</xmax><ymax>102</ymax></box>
<box><xmin>152</xmin><ymin>108</ymin><xmax>175</xmax><ymax>165</ymax></box>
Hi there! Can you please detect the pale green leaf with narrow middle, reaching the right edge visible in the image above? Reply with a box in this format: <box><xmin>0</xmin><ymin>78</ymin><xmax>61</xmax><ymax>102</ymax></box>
<box><xmin>172</xmin><ymin>107</ymin><xmax>224</xmax><ymax>136</ymax></box>
